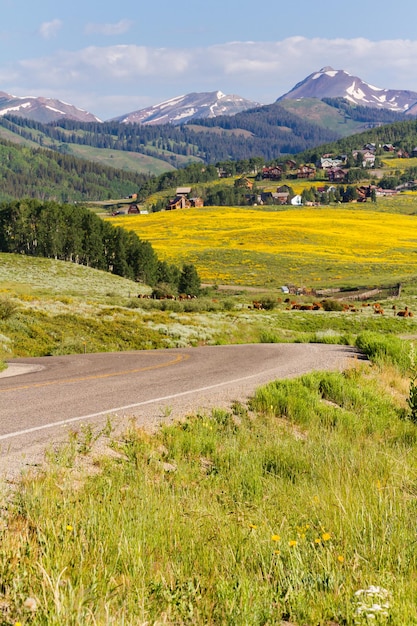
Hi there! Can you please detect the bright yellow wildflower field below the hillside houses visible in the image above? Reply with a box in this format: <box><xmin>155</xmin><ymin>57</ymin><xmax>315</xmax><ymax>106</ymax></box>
<box><xmin>110</xmin><ymin>205</ymin><xmax>417</xmax><ymax>287</ymax></box>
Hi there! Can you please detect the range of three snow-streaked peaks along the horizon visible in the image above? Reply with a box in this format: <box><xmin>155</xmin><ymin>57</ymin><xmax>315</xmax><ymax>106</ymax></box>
<box><xmin>0</xmin><ymin>66</ymin><xmax>417</xmax><ymax>126</ymax></box>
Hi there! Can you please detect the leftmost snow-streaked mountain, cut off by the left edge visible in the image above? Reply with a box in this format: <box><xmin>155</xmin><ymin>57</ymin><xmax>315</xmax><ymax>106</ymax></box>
<box><xmin>0</xmin><ymin>91</ymin><xmax>100</xmax><ymax>124</ymax></box>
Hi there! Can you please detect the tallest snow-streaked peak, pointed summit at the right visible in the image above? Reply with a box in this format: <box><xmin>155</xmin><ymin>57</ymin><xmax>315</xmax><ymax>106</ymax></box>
<box><xmin>277</xmin><ymin>67</ymin><xmax>417</xmax><ymax>115</ymax></box>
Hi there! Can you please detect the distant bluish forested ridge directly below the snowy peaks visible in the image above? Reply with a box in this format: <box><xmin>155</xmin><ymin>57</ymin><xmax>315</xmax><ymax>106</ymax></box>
<box><xmin>0</xmin><ymin>104</ymin><xmax>338</xmax><ymax>165</ymax></box>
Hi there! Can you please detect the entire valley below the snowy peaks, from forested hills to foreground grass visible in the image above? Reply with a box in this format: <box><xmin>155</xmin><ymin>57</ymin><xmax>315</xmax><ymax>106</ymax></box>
<box><xmin>0</xmin><ymin>68</ymin><xmax>417</xmax><ymax>626</ymax></box>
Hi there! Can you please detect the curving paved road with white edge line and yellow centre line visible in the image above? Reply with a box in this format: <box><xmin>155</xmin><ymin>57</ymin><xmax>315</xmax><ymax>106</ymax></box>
<box><xmin>0</xmin><ymin>344</ymin><xmax>355</xmax><ymax>475</ymax></box>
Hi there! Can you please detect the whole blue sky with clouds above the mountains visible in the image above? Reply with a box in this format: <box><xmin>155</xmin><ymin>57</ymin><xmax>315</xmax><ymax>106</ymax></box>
<box><xmin>0</xmin><ymin>0</ymin><xmax>417</xmax><ymax>120</ymax></box>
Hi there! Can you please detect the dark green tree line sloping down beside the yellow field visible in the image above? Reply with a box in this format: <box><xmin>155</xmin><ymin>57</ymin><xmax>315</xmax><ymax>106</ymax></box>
<box><xmin>0</xmin><ymin>199</ymin><xmax>199</xmax><ymax>295</ymax></box>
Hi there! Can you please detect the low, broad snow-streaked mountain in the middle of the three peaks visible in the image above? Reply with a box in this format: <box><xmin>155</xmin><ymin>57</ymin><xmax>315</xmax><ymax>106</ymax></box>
<box><xmin>113</xmin><ymin>91</ymin><xmax>259</xmax><ymax>126</ymax></box>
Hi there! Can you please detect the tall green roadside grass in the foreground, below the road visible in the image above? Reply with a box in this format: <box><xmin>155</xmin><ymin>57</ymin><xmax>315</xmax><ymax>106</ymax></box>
<box><xmin>0</xmin><ymin>365</ymin><xmax>417</xmax><ymax>626</ymax></box>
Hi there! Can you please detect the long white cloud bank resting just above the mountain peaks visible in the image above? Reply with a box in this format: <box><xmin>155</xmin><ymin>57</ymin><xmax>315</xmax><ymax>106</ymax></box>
<box><xmin>6</xmin><ymin>36</ymin><xmax>417</xmax><ymax>119</ymax></box>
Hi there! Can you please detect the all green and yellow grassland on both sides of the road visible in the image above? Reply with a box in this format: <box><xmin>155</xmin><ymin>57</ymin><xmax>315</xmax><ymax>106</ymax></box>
<box><xmin>0</xmin><ymin>196</ymin><xmax>417</xmax><ymax>626</ymax></box>
